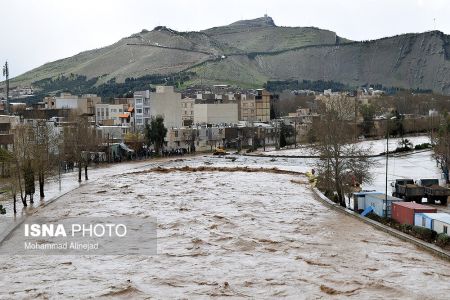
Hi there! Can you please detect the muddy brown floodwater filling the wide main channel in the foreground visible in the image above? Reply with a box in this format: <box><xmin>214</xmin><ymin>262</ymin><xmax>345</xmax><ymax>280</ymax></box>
<box><xmin>0</xmin><ymin>158</ymin><xmax>450</xmax><ymax>299</ymax></box>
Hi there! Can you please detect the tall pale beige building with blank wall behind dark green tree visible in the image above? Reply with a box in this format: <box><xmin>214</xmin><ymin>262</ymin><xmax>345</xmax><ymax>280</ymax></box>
<box><xmin>149</xmin><ymin>86</ymin><xmax>182</xmax><ymax>128</ymax></box>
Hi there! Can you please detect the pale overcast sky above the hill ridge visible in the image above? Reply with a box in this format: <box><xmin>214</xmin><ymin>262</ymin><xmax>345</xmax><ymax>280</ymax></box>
<box><xmin>0</xmin><ymin>0</ymin><xmax>450</xmax><ymax>80</ymax></box>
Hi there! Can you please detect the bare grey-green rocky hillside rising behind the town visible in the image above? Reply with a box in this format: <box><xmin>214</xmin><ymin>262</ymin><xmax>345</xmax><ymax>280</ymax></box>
<box><xmin>14</xmin><ymin>16</ymin><xmax>450</xmax><ymax>94</ymax></box>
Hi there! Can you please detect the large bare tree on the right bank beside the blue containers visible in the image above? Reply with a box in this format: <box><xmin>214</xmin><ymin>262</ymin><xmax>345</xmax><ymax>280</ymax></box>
<box><xmin>313</xmin><ymin>97</ymin><xmax>372</xmax><ymax>206</ymax></box>
